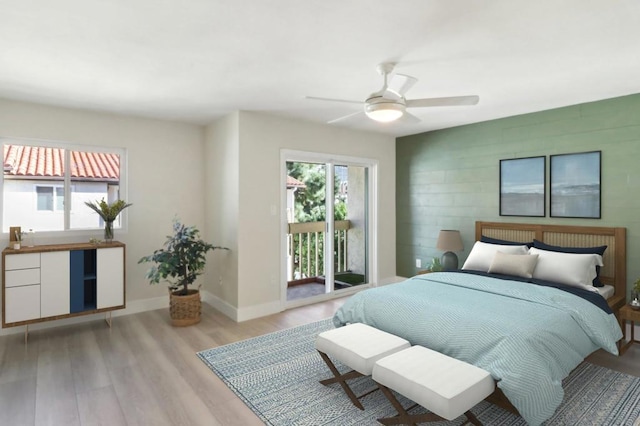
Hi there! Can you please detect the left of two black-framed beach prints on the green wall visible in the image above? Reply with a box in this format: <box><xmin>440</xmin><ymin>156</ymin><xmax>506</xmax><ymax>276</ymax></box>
<box><xmin>500</xmin><ymin>157</ymin><xmax>546</xmax><ymax>217</ymax></box>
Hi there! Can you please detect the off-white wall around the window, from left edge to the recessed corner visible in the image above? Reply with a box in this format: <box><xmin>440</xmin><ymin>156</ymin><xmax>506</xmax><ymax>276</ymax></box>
<box><xmin>0</xmin><ymin>99</ymin><xmax>204</xmax><ymax>303</ymax></box>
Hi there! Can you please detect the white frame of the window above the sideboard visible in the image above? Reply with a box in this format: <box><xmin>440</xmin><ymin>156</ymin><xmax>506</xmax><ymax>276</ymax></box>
<box><xmin>0</xmin><ymin>137</ymin><xmax>128</xmax><ymax>238</ymax></box>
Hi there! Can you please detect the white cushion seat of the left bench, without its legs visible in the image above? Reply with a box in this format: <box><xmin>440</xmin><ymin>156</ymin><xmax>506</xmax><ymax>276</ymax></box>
<box><xmin>316</xmin><ymin>323</ymin><xmax>411</xmax><ymax>376</ymax></box>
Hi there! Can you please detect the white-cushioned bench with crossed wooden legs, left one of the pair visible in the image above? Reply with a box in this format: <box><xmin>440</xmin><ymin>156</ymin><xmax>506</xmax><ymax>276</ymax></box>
<box><xmin>316</xmin><ymin>323</ymin><xmax>411</xmax><ymax>410</ymax></box>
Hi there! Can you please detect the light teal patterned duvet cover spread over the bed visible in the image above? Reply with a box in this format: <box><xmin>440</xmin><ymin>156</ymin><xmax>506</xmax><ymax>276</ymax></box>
<box><xmin>333</xmin><ymin>272</ymin><xmax>622</xmax><ymax>425</ymax></box>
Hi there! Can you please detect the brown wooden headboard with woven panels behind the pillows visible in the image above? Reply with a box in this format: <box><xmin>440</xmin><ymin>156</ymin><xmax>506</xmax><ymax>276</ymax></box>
<box><xmin>476</xmin><ymin>222</ymin><xmax>627</xmax><ymax>313</ymax></box>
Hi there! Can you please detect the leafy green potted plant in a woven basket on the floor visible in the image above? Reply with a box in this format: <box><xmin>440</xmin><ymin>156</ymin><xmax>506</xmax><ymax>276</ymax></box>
<box><xmin>138</xmin><ymin>219</ymin><xmax>229</xmax><ymax>327</ymax></box>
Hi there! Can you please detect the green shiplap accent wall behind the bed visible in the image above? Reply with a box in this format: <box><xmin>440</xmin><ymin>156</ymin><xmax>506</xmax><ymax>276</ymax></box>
<box><xmin>396</xmin><ymin>94</ymin><xmax>640</xmax><ymax>292</ymax></box>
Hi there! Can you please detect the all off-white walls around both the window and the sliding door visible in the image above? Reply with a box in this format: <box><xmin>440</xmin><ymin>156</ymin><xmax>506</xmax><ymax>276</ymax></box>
<box><xmin>0</xmin><ymin>99</ymin><xmax>395</xmax><ymax>326</ymax></box>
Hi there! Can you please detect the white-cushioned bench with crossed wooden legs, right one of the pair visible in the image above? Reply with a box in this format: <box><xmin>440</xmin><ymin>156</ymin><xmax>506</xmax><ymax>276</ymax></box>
<box><xmin>372</xmin><ymin>346</ymin><xmax>495</xmax><ymax>425</ymax></box>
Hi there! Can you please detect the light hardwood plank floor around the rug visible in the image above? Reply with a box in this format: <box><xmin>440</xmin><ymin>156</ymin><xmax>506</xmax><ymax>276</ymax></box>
<box><xmin>0</xmin><ymin>299</ymin><xmax>640</xmax><ymax>426</ymax></box>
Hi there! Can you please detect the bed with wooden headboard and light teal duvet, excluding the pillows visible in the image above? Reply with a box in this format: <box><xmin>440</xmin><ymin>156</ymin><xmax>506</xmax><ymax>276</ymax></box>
<box><xmin>334</xmin><ymin>222</ymin><xmax>626</xmax><ymax>425</ymax></box>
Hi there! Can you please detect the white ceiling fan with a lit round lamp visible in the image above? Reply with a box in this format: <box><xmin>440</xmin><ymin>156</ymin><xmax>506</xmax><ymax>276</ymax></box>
<box><xmin>306</xmin><ymin>62</ymin><xmax>480</xmax><ymax>123</ymax></box>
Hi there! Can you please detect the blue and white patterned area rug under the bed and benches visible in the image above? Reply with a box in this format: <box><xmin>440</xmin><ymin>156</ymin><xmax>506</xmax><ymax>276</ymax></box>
<box><xmin>198</xmin><ymin>319</ymin><xmax>640</xmax><ymax>426</ymax></box>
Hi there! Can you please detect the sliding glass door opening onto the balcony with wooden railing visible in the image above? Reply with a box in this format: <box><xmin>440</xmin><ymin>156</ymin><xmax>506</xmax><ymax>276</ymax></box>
<box><xmin>283</xmin><ymin>155</ymin><xmax>371</xmax><ymax>304</ymax></box>
